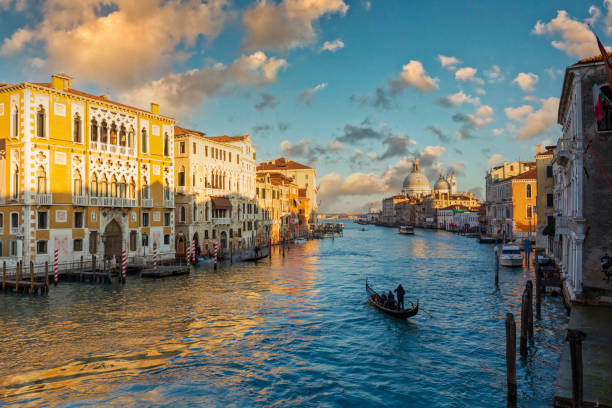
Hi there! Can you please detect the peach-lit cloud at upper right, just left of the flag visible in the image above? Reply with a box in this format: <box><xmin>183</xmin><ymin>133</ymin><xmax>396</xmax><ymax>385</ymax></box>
<box><xmin>533</xmin><ymin>9</ymin><xmax>596</xmax><ymax>58</ymax></box>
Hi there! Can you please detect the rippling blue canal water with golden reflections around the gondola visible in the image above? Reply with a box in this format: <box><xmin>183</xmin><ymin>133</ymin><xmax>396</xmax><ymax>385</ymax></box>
<box><xmin>0</xmin><ymin>223</ymin><xmax>567</xmax><ymax>407</ymax></box>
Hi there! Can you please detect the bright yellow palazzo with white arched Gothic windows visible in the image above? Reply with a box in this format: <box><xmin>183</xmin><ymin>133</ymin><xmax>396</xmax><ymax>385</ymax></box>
<box><xmin>0</xmin><ymin>74</ymin><xmax>175</xmax><ymax>263</ymax></box>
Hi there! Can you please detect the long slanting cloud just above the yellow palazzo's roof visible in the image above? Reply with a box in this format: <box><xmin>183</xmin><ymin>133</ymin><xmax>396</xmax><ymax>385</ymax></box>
<box><xmin>121</xmin><ymin>51</ymin><xmax>288</xmax><ymax>116</ymax></box>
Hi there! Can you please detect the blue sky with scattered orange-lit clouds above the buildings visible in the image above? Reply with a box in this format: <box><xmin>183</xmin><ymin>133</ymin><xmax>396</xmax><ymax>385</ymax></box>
<box><xmin>0</xmin><ymin>0</ymin><xmax>612</xmax><ymax>212</ymax></box>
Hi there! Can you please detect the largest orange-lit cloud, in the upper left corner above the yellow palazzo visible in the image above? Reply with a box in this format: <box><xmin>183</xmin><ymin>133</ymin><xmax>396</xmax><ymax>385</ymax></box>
<box><xmin>0</xmin><ymin>0</ymin><xmax>229</xmax><ymax>90</ymax></box>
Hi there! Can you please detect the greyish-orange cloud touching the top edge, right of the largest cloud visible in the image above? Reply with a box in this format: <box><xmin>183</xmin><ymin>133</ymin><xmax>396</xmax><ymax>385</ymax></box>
<box><xmin>242</xmin><ymin>0</ymin><xmax>349</xmax><ymax>51</ymax></box>
